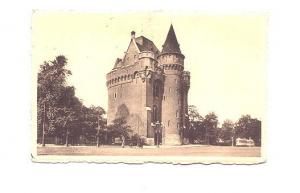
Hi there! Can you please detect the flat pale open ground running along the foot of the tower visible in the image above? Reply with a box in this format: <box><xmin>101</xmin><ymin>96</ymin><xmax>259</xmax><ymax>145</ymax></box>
<box><xmin>37</xmin><ymin>145</ymin><xmax>260</xmax><ymax>157</ymax></box>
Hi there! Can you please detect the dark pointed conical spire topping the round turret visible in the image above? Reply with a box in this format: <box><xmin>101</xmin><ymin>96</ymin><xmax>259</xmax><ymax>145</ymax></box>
<box><xmin>162</xmin><ymin>24</ymin><xmax>181</xmax><ymax>54</ymax></box>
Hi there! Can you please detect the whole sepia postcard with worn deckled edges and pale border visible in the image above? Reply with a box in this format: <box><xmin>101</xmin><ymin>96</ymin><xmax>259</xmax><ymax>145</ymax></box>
<box><xmin>31</xmin><ymin>10</ymin><xmax>268</xmax><ymax>164</ymax></box>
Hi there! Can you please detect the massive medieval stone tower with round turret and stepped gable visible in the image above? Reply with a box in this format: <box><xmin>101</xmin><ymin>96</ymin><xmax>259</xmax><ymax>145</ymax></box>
<box><xmin>106</xmin><ymin>25</ymin><xmax>190</xmax><ymax>145</ymax></box>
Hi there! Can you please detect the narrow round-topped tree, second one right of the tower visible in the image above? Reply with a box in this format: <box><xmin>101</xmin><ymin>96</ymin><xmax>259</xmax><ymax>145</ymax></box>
<box><xmin>203</xmin><ymin>112</ymin><xmax>218</xmax><ymax>145</ymax></box>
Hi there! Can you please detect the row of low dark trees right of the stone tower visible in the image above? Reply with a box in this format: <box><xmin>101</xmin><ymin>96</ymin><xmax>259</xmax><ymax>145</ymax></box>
<box><xmin>188</xmin><ymin>105</ymin><xmax>261</xmax><ymax>146</ymax></box>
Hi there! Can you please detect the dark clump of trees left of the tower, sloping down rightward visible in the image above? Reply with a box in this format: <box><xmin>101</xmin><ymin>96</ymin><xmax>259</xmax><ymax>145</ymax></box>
<box><xmin>37</xmin><ymin>56</ymin><xmax>106</xmax><ymax>145</ymax></box>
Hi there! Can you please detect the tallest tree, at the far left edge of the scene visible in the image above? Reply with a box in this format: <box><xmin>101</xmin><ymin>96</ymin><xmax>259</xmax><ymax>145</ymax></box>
<box><xmin>37</xmin><ymin>55</ymin><xmax>71</xmax><ymax>146</ymax></box>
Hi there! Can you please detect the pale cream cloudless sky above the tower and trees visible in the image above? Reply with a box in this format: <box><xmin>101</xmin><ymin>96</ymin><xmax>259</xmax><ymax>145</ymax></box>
<box><xmin>32</xmin><ymin>11</ymin><xmax>268</xmax><ymax>121</ymax></box>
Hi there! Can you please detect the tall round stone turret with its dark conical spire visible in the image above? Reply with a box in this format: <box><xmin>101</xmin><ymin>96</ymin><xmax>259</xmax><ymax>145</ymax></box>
<box><xmin>157</xmin><ymin>25</ymin><xmax>186</xmax><ymax>145</ymax></box>
